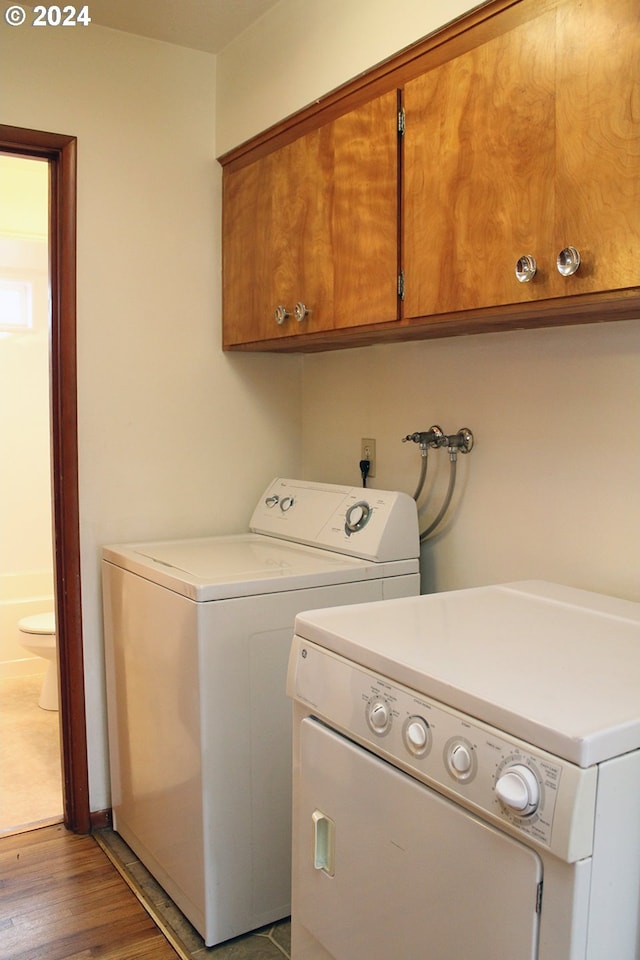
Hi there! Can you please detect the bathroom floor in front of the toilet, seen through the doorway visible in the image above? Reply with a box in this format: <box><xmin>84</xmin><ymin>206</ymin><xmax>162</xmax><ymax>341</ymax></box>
<box><xmin>0</xmin><ymin>676</ymin><xmax>62</xmax><ymax>835</ymax></box>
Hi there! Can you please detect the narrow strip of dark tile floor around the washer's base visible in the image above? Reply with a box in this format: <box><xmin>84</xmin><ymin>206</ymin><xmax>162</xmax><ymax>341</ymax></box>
<box><xmin>94</xmin><ymin>830</ymin><xmax>291</xmax><ymax>960</ymax></box>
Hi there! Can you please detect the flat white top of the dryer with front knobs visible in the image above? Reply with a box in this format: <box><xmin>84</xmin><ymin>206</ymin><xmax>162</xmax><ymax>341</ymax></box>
<box><xmin>295</xmin><ymin>581</ymin><xmax>640</xmax><ymax>767</ymax></box>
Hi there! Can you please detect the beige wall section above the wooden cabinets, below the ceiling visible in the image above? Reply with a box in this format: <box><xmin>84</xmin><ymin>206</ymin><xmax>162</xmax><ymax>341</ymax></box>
<box><xmin>216</xmin><ymin>0</ymin><xmax>476</xmax><ymax>154</ymax></box>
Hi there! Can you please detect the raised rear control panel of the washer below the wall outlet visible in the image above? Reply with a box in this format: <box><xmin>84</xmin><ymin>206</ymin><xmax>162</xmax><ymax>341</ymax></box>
<box><xmin>249</xmin><ymin>478</ymin><xmax>420</xmax><ymax>563</ymax></box>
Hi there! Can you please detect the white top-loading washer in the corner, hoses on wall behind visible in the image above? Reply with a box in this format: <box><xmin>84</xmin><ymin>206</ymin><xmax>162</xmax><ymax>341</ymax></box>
<box><xmin>103</xmin><ymin>479</ymin><xmax>419</xmax><ymax>946</ymax></box>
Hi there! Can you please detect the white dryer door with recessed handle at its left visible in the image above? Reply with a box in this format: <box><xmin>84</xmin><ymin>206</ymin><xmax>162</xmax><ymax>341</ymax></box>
<box><xmin>292</xmin><ymin>718</ymin><xmax>542</xmax><ymax>960</ymax></box>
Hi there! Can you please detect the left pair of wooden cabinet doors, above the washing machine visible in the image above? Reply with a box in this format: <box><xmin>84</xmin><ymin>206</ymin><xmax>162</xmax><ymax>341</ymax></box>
<box><xmin>223</xmin><ymin>90</ymin><xmax>398</xmax><ymax>346</ymax></box>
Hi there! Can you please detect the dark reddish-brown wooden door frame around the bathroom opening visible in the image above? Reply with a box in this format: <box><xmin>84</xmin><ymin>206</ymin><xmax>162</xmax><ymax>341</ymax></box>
<box><xmin>0</xmin><ymin>124</ymin><xmax>91</xmax><ymax>833</ymax></box>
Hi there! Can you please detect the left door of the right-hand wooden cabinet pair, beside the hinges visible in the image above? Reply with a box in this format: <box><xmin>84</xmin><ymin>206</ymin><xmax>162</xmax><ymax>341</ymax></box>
<box><xmin>403</xmin><ymin>13</ymin><xmax>555</xmax><ymax>317</ymax></box>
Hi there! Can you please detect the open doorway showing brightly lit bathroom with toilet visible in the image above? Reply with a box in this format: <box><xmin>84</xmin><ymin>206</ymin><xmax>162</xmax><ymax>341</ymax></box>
<box><xmin>0</xmin><ymin>153</ymin><xmax>62</xmax><ymax>834</ymax></box>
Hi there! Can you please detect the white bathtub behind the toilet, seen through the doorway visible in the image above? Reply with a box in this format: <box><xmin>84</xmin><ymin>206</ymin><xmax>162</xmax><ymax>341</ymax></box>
<box><xmin>0</xmin><ymin>570</ymin><xmax>54</xmax><ymax>679</ymax></box>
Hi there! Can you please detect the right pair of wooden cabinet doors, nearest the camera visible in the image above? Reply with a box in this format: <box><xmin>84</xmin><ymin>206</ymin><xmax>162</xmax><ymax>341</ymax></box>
<box><xmin>404</xmin><ymin>0</ymin><xmax>640</xmax><ymax>317</ymax></box>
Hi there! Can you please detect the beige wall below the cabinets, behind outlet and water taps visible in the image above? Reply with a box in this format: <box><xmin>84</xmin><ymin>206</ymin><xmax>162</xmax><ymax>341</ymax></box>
<box><xmin>303</xmin><ymin>321</ymin><xmax>640</xmax><ymax>600</ymax></box>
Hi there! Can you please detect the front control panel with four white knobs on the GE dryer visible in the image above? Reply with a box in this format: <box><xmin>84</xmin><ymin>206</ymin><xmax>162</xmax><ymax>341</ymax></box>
<box><xmin>288</xmin><ymin>637</ymin><xmax>597</xmax><ymax>860</ymax></box>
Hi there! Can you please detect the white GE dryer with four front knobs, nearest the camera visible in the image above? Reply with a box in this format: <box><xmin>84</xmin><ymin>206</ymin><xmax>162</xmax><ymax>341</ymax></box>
<box><xmin>287</xmin><ymin>582</ymin><xmax>640</xmax><ymax>960</ymax></box>
